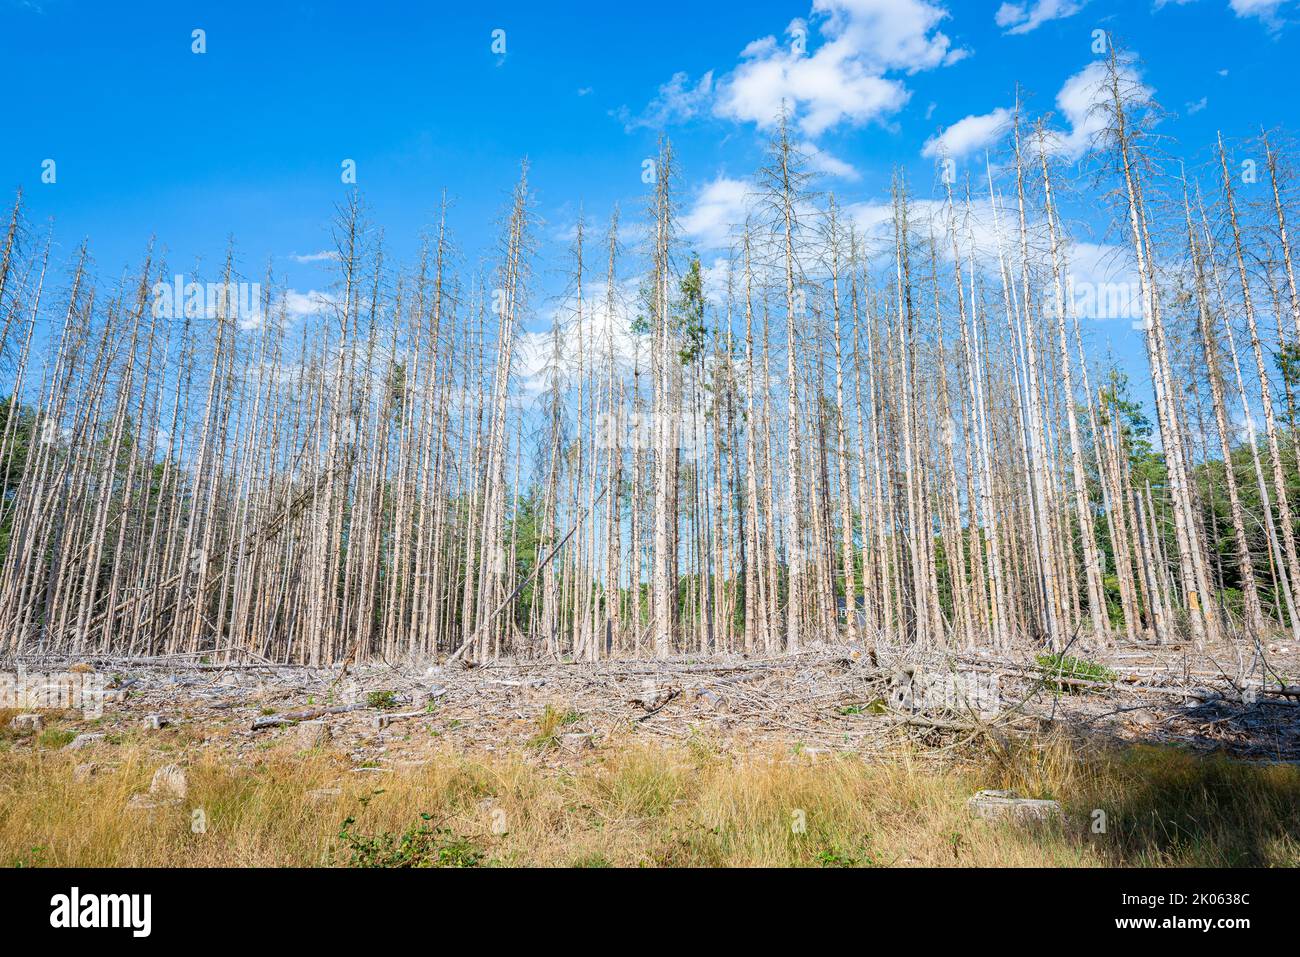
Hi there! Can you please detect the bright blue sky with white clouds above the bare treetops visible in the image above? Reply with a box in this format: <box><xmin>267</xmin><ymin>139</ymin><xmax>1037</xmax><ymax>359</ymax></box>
<box><xmin>0</xmin><ymin>0</ymin><xmax>1300</xmax><ymax>382</ymax></box>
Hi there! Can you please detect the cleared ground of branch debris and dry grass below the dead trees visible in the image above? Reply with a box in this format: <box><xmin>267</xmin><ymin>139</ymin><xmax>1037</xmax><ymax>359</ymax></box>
<box><xmin>0</xmin><ymin>641</ymin><xmax>1300</xmax><ymax>866</ymax></box>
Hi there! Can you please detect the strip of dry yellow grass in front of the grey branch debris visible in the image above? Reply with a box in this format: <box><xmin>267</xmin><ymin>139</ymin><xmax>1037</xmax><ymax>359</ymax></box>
<box><xmin>0</xmin><ymin>717</ymin><xmax>1300</xmax><ymax>867</ymax></box>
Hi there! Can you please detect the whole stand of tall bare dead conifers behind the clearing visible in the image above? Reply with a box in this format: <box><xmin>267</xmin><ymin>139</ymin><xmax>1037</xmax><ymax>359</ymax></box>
<box><xmin>0</xmin><ymin>51</ymin><xmax>1300</xmax><ymax>664</ymax></box>
